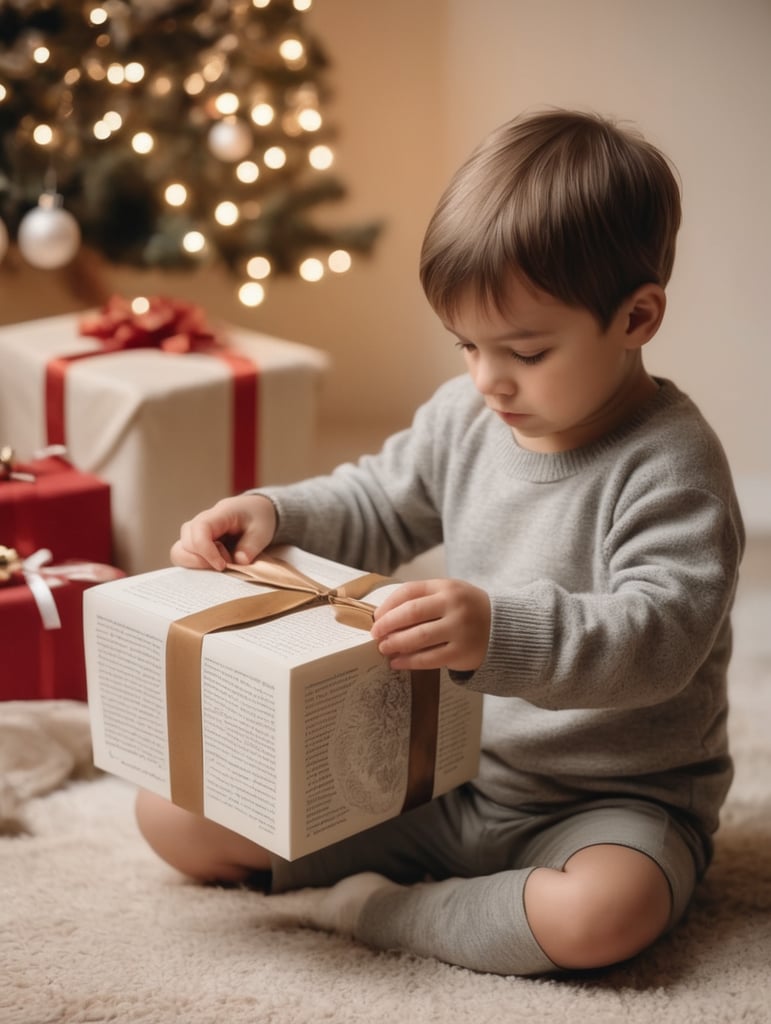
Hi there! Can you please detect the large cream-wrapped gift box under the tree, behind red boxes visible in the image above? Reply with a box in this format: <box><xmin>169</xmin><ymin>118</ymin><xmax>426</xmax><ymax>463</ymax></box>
<box><xmin>0</xmin><ymin>314</ymin><xmax>329</xmax><ymax>573</ymax></box>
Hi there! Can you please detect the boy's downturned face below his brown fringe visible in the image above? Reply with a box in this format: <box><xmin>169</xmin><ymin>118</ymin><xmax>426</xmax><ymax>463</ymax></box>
<box><xmin>445</xmin><ymin>278</ymin><xmax>656</xmax><ymax>452</ymax></box>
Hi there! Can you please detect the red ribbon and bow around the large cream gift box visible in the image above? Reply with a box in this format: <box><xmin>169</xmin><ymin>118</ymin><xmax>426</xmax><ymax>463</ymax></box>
<box><xmin>45</xmin><ymin>295</ymin><xmax>258</xmax><ymax>493</ymax></box>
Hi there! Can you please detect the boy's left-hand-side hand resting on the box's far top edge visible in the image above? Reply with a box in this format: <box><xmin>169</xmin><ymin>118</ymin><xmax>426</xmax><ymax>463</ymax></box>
<box><xmin>171</xmin><ymin>495</ymin><xmax>275</xmax><ymax>570</ymax></box>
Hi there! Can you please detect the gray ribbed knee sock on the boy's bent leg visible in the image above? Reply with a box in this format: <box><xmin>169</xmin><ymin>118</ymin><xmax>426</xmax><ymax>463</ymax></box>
<box><xmin>354</xmin><ymin>870</ymin><xmax>558</xmax><ymax>975</ymax></box>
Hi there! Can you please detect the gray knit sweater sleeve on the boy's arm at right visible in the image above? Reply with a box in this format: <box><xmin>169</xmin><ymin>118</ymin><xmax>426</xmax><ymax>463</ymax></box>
<box><xmin>467</xmin><ymin>487</ymin><xmax>742</xmax><ymax>710</ymax></box>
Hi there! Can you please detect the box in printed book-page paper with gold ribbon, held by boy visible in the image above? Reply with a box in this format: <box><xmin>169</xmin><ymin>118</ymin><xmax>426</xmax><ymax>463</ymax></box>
<box><xmin>84</xmin><ymin>547</ymin><xmax>482</xmax><ymax>860</ymax></box>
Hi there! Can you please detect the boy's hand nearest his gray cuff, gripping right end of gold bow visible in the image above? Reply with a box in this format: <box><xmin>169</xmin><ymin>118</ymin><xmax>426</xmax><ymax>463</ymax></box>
<box><xmin>372</xmin><ymin>580</ymin><xmax>491</xmax><ymax>672</ymax></box>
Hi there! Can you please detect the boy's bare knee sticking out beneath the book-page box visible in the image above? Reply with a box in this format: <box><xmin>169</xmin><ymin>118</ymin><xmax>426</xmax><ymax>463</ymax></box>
<box><xmin>136</xmin><ymin>790</ymin><xmax>270</xmax><ymax>883</ymax></box>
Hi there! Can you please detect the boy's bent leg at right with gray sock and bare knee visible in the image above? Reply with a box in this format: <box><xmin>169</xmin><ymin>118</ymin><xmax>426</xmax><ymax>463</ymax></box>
<box><xmin>310</xmin><ymin>801</ymin><xmax>696</xmax><ymax>975</ymax></box>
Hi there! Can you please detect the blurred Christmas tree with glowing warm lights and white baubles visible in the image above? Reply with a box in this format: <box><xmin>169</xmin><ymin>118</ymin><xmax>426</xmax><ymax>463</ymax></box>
<box><xmin>0</xmin><ymin>0</ymin><xmax>379</xmax><ymax>305</ymax></box>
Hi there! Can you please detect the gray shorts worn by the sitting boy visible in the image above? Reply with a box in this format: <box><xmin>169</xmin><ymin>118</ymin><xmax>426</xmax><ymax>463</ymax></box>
<box><xmin>271</xmin><ymin>785</ymin><xmax>705</xmax><ymax>927</ymax></box>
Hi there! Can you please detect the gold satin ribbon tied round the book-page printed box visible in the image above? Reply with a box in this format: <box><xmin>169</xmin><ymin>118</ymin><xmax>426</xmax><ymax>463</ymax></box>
<box><xmin>166</xmin><ymin>555</ymin><xmax>439</xmax><ymax>814</ymax></box>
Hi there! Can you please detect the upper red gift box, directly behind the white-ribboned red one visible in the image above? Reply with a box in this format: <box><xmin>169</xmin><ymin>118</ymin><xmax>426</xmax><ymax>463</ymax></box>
<box><xmin>0</xmin><ymin>457</ymin><xmax>113</xmax><ymax>563</ymax></box>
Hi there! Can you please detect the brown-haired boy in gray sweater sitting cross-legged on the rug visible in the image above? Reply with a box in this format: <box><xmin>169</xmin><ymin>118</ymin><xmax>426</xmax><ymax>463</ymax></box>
<box><xmin>137</xmin><ymin>111</ymin><xmax>743</xmax><ymax>975</ymax></box>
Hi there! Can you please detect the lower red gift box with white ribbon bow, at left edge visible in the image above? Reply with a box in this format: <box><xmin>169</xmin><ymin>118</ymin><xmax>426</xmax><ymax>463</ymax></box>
<box><xmin>0</xmin><ymin>562</ymin><xmax>124</xmax><ymax>700</ymax></box>
